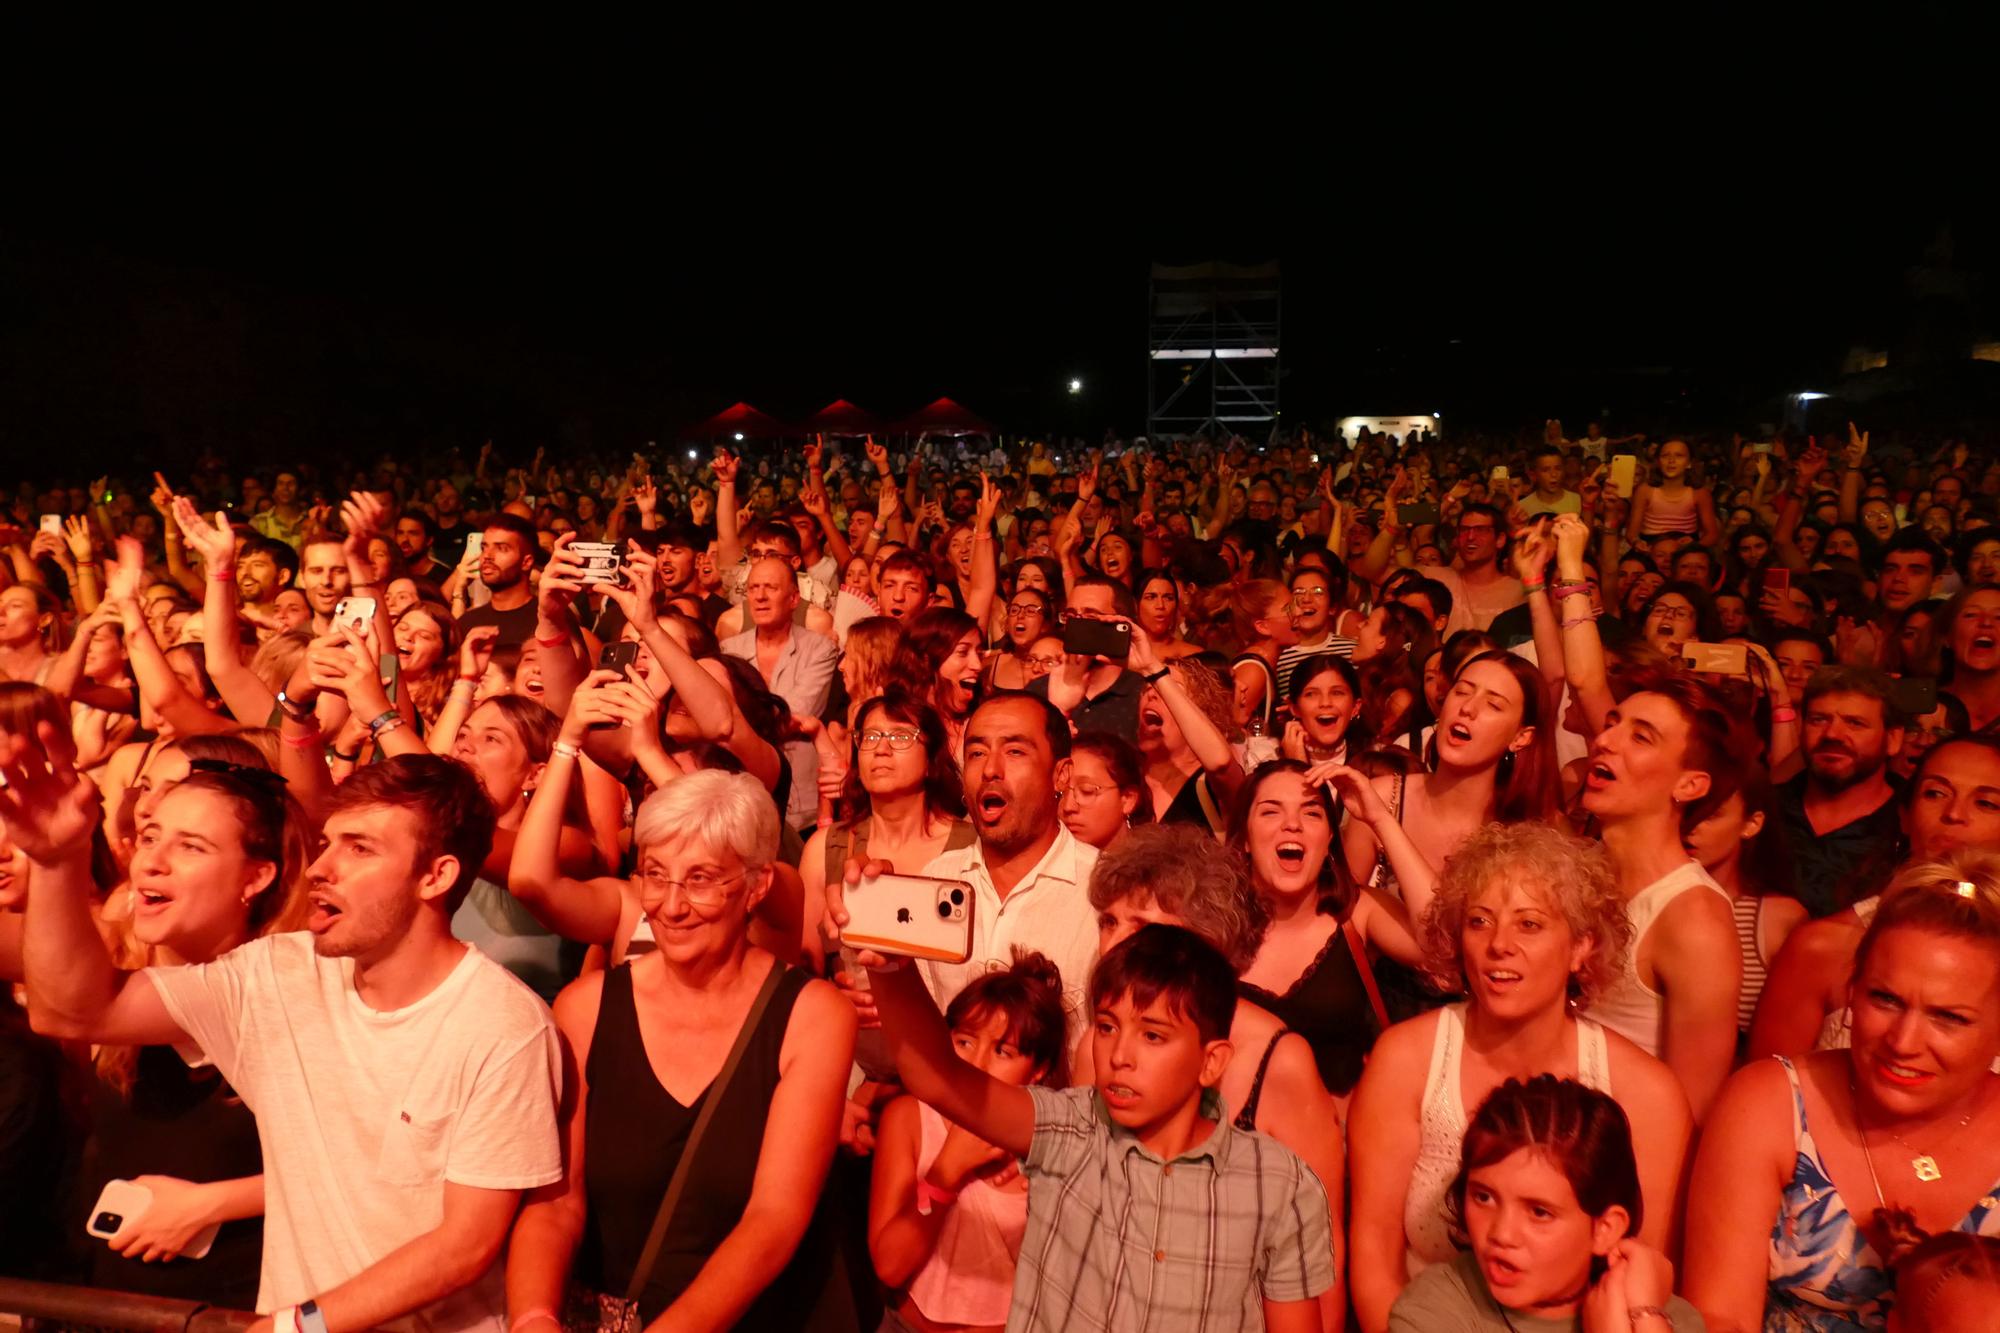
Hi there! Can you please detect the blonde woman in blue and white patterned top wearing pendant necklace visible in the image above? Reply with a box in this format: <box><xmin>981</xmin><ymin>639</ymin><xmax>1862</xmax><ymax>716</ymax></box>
<box><xmin>1684</xmin><ymin>851</ymin><xmax>2000</xmax><ymax>1333</ymax></box>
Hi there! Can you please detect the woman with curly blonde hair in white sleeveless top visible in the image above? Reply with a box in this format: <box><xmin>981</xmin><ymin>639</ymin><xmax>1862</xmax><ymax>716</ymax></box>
<box><xmin>1348</xmin><ymin>823</ymin><xmax>1694</xmax><ymax>1333</ymax></box>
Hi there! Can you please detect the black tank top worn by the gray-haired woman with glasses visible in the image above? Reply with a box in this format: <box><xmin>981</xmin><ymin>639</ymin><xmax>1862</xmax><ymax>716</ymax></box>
<box><xmin>576</xmin><ymin>963</ymin><xmax>858</xmax><ymax>1333</ymax></box>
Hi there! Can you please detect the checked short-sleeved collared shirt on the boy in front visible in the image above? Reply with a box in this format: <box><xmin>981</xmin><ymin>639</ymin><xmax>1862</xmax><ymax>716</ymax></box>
<box><xmin>1006</xmin><ymin>1087</ymin><xmax>1334</xmax><ymax>1333</ymax></box>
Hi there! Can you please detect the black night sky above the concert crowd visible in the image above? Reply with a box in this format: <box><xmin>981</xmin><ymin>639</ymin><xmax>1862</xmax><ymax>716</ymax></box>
<box><xmin>0</xmin><ymin>16</ymin><xmax>1996</xmax><ymax>468</ymax></box>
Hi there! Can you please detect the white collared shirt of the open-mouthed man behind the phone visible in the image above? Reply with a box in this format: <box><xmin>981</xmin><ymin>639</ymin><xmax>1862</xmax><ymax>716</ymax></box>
<box><xmin>918</xmin><ymin>823</ymin><xmax>1098</xmax><ymax>1043</ymax></box>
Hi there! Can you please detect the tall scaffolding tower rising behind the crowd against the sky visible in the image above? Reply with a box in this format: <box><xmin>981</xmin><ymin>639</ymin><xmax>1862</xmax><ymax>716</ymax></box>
<box><xmin>1146</xmin><ymin>262</ymin><xmax>1280</xmax><ymax>436</ymax></box>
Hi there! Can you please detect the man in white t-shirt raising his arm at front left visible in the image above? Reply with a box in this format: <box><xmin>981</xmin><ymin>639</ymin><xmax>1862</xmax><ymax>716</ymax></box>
<box><xmin>15</xmin><ymin>741</ymin><xmax>562</xmax><ymax>1333</ymax></box>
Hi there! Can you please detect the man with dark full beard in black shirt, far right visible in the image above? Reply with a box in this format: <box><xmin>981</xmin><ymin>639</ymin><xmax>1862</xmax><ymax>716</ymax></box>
<box><xmin>1780</xmin><ymin>667</ymin><xmax>1904</xmax><ymax>917</ymax></box>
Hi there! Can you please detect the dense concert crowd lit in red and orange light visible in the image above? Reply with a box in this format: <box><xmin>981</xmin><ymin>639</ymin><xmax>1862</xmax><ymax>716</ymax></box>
<box><xmin>0</xmin><ymin>420</ymin><xmax>2000</xmax><ymax>1333</ymax></box>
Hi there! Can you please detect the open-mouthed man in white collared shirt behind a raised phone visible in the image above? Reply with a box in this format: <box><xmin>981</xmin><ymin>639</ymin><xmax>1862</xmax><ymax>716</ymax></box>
<box><xmin>826</xmin><ymin>691</ymin><xmax>1098</xmax><ymax>1045</ymax></box>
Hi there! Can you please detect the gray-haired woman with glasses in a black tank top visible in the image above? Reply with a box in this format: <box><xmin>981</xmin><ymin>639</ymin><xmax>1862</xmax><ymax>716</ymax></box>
<box><xmin>508</xmin><ymin>769</ymin><xmax>858</xmax><ymax>1333</ymax></box>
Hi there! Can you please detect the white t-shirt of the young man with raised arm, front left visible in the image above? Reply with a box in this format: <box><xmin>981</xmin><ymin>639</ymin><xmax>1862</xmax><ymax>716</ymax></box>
<box><xmin>146</xmin><ymin>931</ymin><xmax>562</xmax><ymax>1333</ymax></box>
